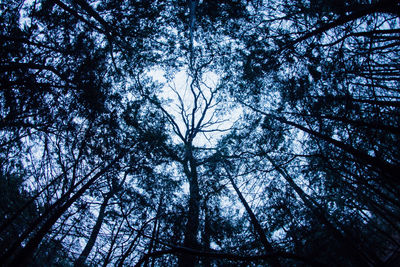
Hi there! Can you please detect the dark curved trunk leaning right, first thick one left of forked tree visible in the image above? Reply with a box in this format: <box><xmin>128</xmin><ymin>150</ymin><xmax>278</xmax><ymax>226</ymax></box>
<box><xmin>74</xmin><ymin>192</ymin><xmax>113</xmax><ymax>267</ymax></box>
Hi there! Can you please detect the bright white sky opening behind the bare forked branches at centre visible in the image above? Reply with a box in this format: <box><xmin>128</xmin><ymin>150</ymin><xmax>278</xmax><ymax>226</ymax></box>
<box><xmin>149</xmin><ymin>69</ymin><xmax>241</xmax><ymax>148</ymax></box>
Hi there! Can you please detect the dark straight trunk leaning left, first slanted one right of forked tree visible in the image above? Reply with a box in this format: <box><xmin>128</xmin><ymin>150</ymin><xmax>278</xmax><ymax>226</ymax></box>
<box><xmin>225</xmin><ymin>168</ymin><xmax>281</xmax><ymax>267</ymax></box>
